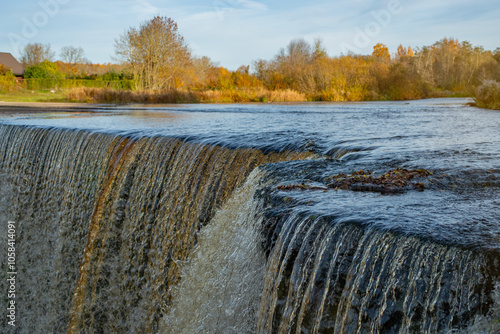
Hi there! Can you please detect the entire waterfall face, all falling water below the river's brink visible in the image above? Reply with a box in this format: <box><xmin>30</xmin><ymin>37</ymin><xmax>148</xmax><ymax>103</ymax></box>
<box><xmin>0</xmin><ymin>125</ymin><xmax>500</xmax><ymax>334</ymax></box>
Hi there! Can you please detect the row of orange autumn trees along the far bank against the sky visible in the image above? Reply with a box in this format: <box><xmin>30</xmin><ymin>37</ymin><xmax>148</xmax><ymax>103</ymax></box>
<box><xmin>2</xmin><ymin>16</ymin><xmax>500</xmax><ymax>105</ymax></box>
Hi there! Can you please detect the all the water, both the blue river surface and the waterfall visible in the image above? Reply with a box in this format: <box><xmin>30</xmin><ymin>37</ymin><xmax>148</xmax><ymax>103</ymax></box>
<box><xmin>0</xmin><ymin>102</ymin><xmax>500</xmax><ymax>334</ymax></box>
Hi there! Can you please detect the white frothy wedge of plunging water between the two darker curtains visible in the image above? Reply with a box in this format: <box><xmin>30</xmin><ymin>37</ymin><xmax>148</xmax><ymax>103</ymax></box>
<box><xmin>159</xmin><ymin>169</ymin><xmax>265</xmax><ymax>334</ymax></box>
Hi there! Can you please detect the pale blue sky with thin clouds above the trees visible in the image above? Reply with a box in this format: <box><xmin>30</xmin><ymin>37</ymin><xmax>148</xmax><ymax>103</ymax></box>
<box><xmin>0</xmin><ymin>0</ymin><xmax>500</xmax><ymax>70</ymax></box>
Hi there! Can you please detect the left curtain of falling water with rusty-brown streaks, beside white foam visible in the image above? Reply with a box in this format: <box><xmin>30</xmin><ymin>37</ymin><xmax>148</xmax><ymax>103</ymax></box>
<box><xmin>0</xmin><ymin>125</ymin><xmax>306</xmax><ymax>333</ymax></box>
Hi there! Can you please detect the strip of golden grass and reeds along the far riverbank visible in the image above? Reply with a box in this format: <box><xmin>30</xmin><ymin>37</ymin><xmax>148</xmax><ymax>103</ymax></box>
<box><xmin>0</xmin><ymin>80</ymin><xmax>492</xmax><ymax>105</ymax></box>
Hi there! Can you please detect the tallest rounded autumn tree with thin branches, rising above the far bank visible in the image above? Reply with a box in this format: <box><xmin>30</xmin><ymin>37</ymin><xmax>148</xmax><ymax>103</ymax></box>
<box><xmin>115</xmin><ymin>16</ymin><xmax>190</xmax><ymax>89</ymax></box>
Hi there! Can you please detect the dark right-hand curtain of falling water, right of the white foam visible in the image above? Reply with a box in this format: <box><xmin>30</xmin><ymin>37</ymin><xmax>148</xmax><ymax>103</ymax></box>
<box><xmin>258</xmin><ymin>213</ymin><xmax>500</xmax><ymax>333</ymax></box>
